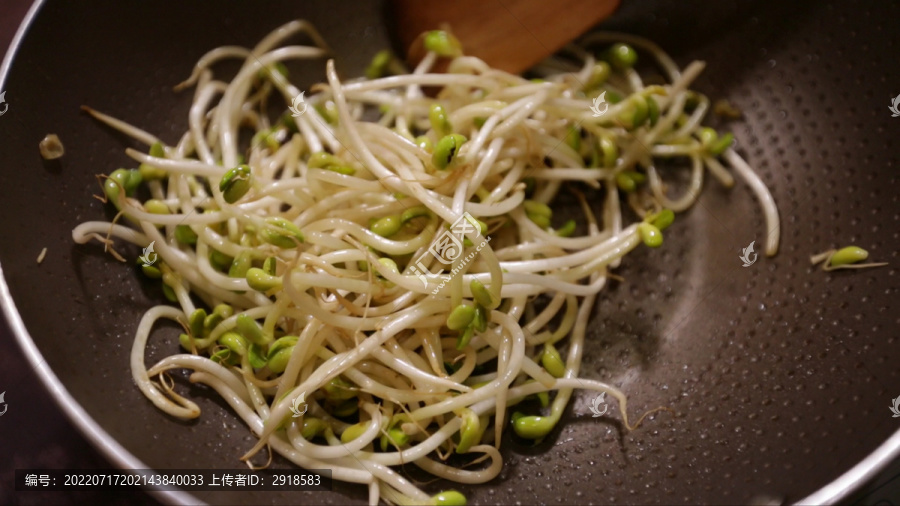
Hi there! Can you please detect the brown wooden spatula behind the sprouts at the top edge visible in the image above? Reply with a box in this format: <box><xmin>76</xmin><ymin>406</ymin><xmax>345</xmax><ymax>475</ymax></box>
<box><xmin>393</xmin><ymin>0</ymin><xmax>619</xmax><ymax>74</ymax></box>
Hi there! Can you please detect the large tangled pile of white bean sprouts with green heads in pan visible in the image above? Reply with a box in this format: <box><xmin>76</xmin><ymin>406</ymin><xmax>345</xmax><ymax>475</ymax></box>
<box><xmin>73</xmin><ymin>21</ymin><xmax>779</xmax><ymax>504</ymax></box>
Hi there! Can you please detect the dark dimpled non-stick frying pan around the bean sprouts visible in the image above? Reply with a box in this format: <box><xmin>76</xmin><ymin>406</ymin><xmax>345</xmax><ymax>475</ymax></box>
<box><xmin>0</xmin><ymin>0</ymin><xmax>900</xmax><ymax>504</ymax></box>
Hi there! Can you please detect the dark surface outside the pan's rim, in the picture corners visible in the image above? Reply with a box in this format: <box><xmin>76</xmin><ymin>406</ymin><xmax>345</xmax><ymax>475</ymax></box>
<box><xmin>0</xmin><ymin>0</ymin><xmax>900</xmax><ymax>505</ymax></box>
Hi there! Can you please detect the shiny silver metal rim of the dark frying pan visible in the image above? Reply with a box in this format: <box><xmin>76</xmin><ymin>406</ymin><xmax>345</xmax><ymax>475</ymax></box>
<box><xmin>0</xmin><ymin>0</ymin><xmax>900</xmax><ymax>505</ymax></box>
